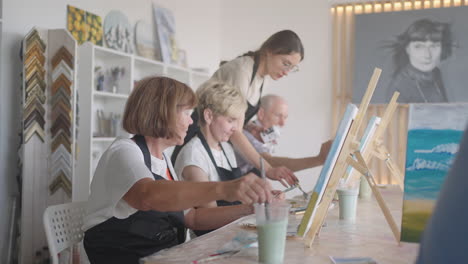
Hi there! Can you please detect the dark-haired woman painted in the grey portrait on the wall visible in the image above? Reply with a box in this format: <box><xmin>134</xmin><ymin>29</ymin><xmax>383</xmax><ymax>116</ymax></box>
<box><xmin>387</xmin><ymin>19</ymin><xmax>453</xmax><ymax>103</ymax></box>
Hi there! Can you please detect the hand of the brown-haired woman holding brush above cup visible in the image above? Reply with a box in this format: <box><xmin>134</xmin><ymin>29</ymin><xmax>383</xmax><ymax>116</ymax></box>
<box><xmin>220</xmin><ymin>173</ymin><xmax>273</xmax><ymax>204</ymax></box>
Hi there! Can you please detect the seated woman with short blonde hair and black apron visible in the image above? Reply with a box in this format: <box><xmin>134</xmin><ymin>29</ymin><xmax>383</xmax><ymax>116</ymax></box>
<box><xmin>175</xmin><ymin>83</ymin><xmax>282</xmax><ymax>235</ymax></box>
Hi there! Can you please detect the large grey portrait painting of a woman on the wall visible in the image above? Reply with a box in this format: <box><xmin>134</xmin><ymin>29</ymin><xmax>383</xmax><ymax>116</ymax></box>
<box><xmin>353</xmin><ymin>6</ymin><xmax>468</xmax><ymax>104</ymax></box>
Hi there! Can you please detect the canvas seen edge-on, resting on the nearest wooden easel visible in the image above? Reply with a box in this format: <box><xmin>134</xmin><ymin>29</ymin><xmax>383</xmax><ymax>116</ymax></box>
<box><xmin>297</xmin><ymin>104</ymin><xmax>358</xmax><ymax>236</ymax></box>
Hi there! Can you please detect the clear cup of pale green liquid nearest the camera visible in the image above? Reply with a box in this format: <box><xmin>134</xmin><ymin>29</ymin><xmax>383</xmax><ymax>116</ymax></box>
<box><xmin>254</xmin><ymin>201</ymin><xmax>291</xmax><ymax>264</ymax></box>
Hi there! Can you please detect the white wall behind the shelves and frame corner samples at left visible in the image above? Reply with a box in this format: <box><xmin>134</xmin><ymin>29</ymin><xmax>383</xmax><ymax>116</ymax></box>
<box><xmin>0</xmin><ymin>0</ymin><xmax>221</xmax><ymax>263</ymax></box>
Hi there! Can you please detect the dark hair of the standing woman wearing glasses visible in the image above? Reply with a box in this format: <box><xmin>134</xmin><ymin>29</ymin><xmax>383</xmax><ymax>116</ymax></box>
<box><xmin>242</xmin><ymin>30</ymin><xmax>304</xmax><ymax>61</ymax></box>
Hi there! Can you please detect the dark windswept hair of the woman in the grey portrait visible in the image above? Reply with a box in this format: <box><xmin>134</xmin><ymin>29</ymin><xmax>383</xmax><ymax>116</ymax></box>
<box><xmin>385</xmin><ymin>18</ymin><xmax>453</xmax><ymax>77</ymax></box>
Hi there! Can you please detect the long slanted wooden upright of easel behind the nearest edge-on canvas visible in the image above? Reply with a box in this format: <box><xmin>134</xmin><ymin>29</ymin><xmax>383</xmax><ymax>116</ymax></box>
<box><xmin>304</xmin><ymin>68</ymin><xmax>382</xmax><ymax>247</ymax></box>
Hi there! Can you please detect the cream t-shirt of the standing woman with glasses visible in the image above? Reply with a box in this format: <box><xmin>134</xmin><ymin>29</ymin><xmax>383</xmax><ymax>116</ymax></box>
<box><xmin>208</xmin><ymin>56</ymin><xmax>266</xmax><ymax>105</ymax></box>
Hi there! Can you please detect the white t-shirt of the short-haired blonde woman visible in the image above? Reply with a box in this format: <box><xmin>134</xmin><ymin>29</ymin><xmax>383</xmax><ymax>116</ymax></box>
<box><xmin>174</xmin><ymin>136</ymin><xmax>237</xmax><ymax>181</ymax></box>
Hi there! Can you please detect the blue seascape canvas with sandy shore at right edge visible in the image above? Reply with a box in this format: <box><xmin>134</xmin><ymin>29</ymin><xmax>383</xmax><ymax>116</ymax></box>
<box><xmin>401</xmin><ymin>104</ymin><xmax>468</xmax><ymax>242</ymax></box>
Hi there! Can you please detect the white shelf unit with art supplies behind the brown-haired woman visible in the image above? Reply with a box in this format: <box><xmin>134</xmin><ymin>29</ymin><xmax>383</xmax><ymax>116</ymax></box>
<box><xmin>73</xmin><ymin>42</ymin><xmax>210</xmax><ymax>201</ymax></box>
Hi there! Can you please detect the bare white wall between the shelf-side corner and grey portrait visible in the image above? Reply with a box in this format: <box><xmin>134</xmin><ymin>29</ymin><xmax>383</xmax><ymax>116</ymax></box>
<box><xmin>221</xmin><ymin>0</ymin><xmax>331</xmax><ymax>196</ymax></box>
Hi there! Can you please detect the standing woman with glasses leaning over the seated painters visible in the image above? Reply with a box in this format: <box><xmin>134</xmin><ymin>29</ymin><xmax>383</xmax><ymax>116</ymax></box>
<box><xmin>172</xmin><ymin>30</ymin><xmax>304</xmax><ymax>185</ymax></box>
